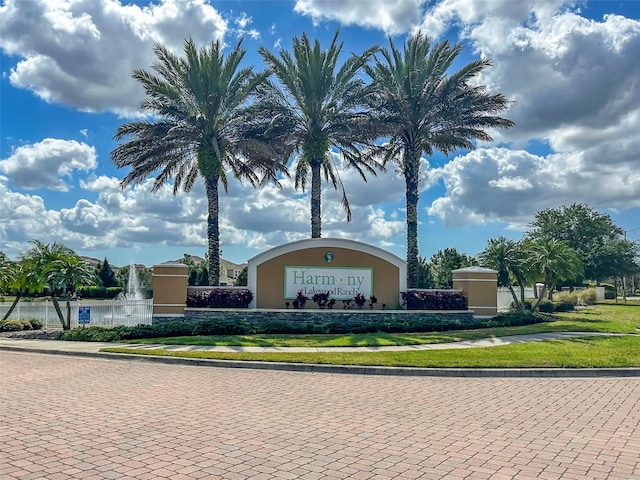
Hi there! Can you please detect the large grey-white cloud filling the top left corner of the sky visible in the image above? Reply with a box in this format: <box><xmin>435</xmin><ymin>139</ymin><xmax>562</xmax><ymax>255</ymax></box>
<box><xmin>0</xmin><ymin>0</ymin><xmax>227</xmax><ymax>114</ymax></box>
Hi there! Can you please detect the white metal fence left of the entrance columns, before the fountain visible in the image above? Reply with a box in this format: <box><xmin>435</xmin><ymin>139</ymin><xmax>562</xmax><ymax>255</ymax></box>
<box><xmin>0</xmin><ymin>300</ymin><xmax>153</xmax><ymax>328</ymax></box>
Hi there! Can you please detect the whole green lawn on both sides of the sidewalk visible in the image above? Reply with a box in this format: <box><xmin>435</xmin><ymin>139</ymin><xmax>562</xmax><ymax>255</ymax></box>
<box><xmin>102</xmin><ymin>302</ymin><xmax>640</xmax><ymax>368</ymax></box>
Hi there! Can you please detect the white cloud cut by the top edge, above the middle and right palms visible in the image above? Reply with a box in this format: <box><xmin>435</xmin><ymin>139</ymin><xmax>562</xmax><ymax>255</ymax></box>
<box><xmin>294</xmin><ymin>0</ymin><xmax>425</xmax><ymax>34</ymax></box>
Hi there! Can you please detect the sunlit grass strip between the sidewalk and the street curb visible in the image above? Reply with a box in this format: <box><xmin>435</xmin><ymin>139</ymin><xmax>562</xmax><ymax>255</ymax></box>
<box><xmin>102</xmin><ymin>336</ymin><xmax>640</xmax><ymax>368</ymax></box>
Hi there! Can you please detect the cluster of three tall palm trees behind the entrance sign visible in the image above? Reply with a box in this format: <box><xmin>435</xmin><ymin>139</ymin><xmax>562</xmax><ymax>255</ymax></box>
<box><xmin>111</xmin><ymin>32</ymin><xmax>513</xmax><ymax>287</ymax></box>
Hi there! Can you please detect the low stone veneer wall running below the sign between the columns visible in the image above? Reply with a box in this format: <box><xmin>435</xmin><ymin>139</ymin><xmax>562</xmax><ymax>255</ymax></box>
<box><xmin>153</xmin><ymin>308</ymin><xmax>476</xmax><ymax>325</ymax></box>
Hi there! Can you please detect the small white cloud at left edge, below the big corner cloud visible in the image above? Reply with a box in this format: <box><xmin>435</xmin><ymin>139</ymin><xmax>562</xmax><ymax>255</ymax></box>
<box><xmin>0</xmin><ymin>138</ymin><xmax>98</xmax><ymax>192</ymax></box>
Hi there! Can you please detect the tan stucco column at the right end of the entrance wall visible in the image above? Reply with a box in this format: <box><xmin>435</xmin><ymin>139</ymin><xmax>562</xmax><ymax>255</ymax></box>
<box><xmin>453</xmin><ymin>267</ymin><xmax>498</xmax><ymax>316</ymax></box>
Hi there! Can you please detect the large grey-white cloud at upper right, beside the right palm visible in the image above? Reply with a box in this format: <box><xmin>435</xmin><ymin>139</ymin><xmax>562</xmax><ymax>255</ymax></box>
<box><xmin>470</xmin><ymin>12</ymin><xmax>640</xmax><ymax>152</ymax></box>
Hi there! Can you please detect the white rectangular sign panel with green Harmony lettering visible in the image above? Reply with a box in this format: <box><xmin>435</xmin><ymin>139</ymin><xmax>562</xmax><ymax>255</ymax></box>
<box><xmin>284</xmin><ymin>266</ymin><xmax>373</xmax><ymax>300</ymax></box>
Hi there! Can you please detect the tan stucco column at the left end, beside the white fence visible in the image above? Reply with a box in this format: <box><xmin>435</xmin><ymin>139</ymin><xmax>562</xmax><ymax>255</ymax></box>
<box><xmin>153</xmin><ymin>263</ymin><xmax>189</xmax><ymax>317</ymax></box>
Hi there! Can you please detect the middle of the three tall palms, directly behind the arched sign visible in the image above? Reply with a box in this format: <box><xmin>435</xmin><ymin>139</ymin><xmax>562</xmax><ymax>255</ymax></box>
<box><xmin>252</xmin><ymin>31</ymin><xmax>381</xmax><ymax>238</ymax></box>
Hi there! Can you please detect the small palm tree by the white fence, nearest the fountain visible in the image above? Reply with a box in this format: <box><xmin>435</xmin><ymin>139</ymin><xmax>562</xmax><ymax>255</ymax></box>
<box><xmin>47</xmin><ymin>255</ymin><xmax>96</xmax><ymax>330</ymax></box>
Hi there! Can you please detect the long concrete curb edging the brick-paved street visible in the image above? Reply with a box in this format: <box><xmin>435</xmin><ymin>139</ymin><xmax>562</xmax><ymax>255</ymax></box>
<box><xmin>0</xmin><ymin>345</ymin><xmax>640</xmax><ymax>378</ymax></box>
